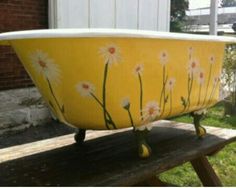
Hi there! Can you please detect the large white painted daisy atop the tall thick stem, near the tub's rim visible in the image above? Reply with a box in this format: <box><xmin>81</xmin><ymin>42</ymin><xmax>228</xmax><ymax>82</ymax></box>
<box><xmin>99</xmin><ymin>44</ymin><xmax>121</xmax><ymax>64</ymax></box>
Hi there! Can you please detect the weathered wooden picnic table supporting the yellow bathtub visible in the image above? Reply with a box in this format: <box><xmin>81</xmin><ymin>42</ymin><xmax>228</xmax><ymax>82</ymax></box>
<box><xmin>0</xmin><ymin>121</ymin><xmax>236</xmax><ymax>186</ymax></box>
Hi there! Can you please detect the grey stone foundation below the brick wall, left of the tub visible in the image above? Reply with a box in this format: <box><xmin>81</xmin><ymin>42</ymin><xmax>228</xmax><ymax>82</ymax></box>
<box><xmin>0</xmin><ymin>87</ymin><xmax>51</xmax><ymax>135</ymax></box>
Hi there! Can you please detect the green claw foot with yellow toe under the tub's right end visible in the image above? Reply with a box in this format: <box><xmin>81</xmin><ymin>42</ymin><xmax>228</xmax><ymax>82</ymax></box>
<box><xmin>191</xmin><ymin>112</ymin><xmax>206</xmax><ymax>138</ymax></box>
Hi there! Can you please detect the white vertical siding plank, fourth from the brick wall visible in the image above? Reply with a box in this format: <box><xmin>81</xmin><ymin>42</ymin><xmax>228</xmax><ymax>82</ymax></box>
<box><xmin>139</xmin><ymin>0</ymin><xmax>157</xmax><ymax>31</ymax></box>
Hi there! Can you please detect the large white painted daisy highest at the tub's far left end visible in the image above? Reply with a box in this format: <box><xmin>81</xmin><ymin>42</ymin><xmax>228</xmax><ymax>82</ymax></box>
<box><xmin>30</xmin><ymin>50</ymin><xmax>60</xmax><ymax>83</ymax></box>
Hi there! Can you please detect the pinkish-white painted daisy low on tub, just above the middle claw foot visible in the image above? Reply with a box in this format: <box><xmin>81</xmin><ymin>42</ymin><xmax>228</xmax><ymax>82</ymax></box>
<box><xmin>143</xmin><ymin>101</ymin><xmax>161</xmax><ymax>122</ymax></box>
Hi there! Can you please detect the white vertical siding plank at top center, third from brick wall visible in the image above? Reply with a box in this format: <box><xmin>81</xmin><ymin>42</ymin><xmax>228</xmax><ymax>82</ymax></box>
<box><xmin>116</xmin><ymin>0</ymin><xmax>139</xmax><ymax>29</ymax></box>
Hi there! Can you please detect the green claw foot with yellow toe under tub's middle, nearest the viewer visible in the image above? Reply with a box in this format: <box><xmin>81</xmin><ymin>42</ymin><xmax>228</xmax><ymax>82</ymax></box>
<box><xmin>134</xmin><ymin>130</ymin><xmax>152</xmax><ymax>159</ymax></box>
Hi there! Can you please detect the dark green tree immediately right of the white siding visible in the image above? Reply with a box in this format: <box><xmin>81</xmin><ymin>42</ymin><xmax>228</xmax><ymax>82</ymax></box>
<box><xmin>170</xmin><ymin>0</ymin><xmax>189</xmax><ymax>32</ymax></box>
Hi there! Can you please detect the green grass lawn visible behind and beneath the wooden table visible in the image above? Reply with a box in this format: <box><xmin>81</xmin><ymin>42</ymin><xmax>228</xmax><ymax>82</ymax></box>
<box><xmin>160</xmin><ymin>104</ymin><xmax>236</xmax><ymax>186</ymax></box>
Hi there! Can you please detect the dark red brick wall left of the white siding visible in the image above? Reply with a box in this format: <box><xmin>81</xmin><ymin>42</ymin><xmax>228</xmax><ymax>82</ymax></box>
<box><xmin>0</xmin><ymin>0</ymin><xmax>48</xmax><ymax>90</ymax></box>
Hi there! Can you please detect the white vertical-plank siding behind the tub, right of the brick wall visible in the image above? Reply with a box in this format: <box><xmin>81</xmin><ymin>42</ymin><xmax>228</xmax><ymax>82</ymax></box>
<box><xmin>49</xmin><ymin>0</ymin><xmax>170</xmax><ymax>31</ymax></box>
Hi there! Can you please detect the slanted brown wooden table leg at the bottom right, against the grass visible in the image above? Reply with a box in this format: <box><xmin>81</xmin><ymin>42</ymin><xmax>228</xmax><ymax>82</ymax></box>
<box><xmin>191</xmin><ymin>155</ymin><xmax>222</xmax><ymax>186</ymax></box>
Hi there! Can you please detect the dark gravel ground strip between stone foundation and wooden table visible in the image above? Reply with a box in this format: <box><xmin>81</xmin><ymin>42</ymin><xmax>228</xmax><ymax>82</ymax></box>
<box><xmin>0</xmin><ymin>121</ymin><xmax>75</xmax><ymax>149</ymax></box>
